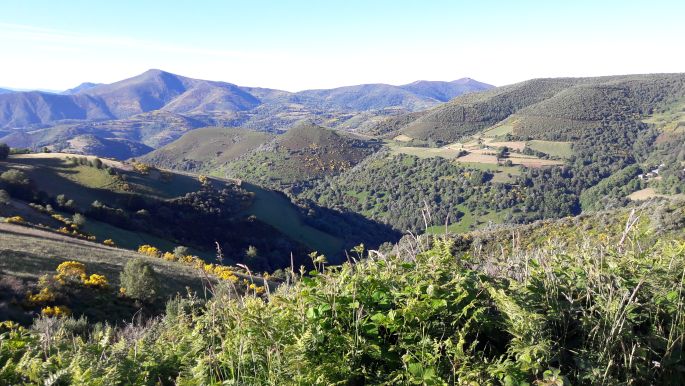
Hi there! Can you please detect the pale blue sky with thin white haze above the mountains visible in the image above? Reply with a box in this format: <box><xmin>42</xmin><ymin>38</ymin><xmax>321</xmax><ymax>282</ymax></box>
<box><xmin>0</xmin><ymin>0</ymin><xmax>685</xmax><ymax>91</ymax></box>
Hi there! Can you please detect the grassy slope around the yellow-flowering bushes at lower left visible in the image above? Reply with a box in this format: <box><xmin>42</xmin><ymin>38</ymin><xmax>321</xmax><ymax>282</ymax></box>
<box><xmin>0</xmin><ymin>222</ymin><xmax>203</xmax><ymax>323</ymax></box>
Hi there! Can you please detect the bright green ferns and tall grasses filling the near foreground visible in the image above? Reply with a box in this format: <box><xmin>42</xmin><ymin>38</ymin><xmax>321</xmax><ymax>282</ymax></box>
<box><xmin>0</xmin><ymin>203</ymin><xmax>685</xmax><ymax>385</ymax></box>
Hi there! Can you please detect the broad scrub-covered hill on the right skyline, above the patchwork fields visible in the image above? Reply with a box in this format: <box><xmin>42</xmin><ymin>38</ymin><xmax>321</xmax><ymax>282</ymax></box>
<box><xmin>377</xmin><ymin>74</ymin><xmax>685</xmax><ymax>142</ymax></box>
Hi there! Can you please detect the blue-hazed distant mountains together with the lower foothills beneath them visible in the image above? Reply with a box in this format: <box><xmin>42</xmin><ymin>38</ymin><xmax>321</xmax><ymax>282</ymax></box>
<box><xmin>0</xmin><ymin>70</ymin><xmax>491</xmax><ymax>156</ymax></box>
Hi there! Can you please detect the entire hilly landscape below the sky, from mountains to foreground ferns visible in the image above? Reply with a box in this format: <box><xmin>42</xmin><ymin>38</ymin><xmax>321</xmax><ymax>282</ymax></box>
<box><xmin>0</xmin><ymin>70</ymin><xmax>685</xmax><ymax>385</ymax></box>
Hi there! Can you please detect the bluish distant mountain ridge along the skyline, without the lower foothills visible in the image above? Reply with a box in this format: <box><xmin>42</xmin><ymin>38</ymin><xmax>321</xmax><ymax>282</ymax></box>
<box><xmin>0</xmin><ymin>69</ymin><xmax>492</xmax><ymax>128</ymax></box>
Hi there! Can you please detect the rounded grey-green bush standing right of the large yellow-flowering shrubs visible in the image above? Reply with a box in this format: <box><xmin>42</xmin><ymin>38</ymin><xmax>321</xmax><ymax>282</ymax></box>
<box><xmin>119</xmin><ymin>258</ymin><xmax>159</xmax><ymax>302</ymax></box>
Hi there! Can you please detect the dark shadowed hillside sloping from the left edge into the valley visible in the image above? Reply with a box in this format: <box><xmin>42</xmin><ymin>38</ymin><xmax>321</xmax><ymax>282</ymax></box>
<box><xmin>0</xmin><ymin>153</ymin><xmax>398</xmax><ymax>270</ymax></box>
